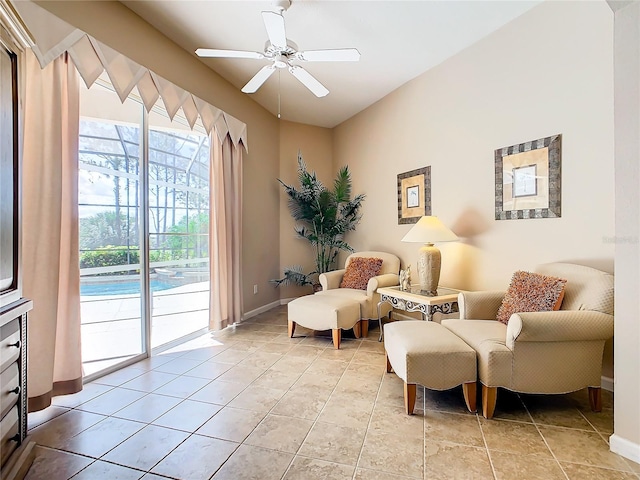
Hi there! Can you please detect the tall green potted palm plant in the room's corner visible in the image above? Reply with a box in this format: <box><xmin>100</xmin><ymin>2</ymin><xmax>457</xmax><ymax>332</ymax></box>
<box><xmin>271</xmin><ymin>152</ymin><xmax>365</xmax><ymax>286</ymax></box>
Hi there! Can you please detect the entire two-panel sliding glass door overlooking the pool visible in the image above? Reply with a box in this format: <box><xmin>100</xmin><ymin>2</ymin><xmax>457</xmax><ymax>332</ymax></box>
<box><xmin>78</xmin><ymin>77</ymin><xmax>209</xmax><ymax>376</ymax></box>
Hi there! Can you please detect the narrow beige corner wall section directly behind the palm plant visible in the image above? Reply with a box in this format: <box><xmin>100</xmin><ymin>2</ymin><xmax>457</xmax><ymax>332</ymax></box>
<box><xmin>278</xmin><ymin>121</ymin><xmax>337</xmax><ymax>299</ymax></box>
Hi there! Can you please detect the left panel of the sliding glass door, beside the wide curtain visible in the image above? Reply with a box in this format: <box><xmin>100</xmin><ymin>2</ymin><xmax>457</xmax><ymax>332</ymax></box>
<box><xmin>78</xmin><ymin>84</ymin><xmax>144</xmax><ymax>375</ymax></box>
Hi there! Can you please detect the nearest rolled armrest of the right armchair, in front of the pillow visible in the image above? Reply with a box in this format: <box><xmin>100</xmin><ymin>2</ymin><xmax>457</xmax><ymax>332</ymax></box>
<box><xmin>506</xmin><ymin>310</ymin><xmax>613</xmax><ymax>349</ymax></box>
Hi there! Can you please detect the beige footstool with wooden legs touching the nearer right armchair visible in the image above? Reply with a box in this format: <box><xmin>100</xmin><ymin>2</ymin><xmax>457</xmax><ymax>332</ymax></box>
<box><xmin>384</xmin><ymin>320</ymin><xmax>477</xmax><ymax>415</ymax></box>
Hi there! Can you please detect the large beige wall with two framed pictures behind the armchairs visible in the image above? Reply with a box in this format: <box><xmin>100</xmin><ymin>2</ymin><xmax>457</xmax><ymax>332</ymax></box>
<box><xmin>334</xmin><ymin>2</ymin><xmax>615</xmax><ymax>376</ymax></box>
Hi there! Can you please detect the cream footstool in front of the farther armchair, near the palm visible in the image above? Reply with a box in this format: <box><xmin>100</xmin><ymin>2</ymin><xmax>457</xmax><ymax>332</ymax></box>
<box><xmin>287</xmin><ymin>295</ymin><xmax>368</xmax><ymax>349</ymax></box>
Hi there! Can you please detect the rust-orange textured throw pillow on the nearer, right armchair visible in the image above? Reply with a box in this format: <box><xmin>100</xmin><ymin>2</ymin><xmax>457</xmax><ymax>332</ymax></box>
<box><xmin>496</xmin><ymin>271</ymin><xmax>567</xmax><ymax>324</ymax></box>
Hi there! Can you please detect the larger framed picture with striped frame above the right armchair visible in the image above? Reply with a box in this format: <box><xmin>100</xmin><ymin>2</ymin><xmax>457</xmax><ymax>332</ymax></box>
<box><xmin>495</xmin><ymin>134</ymin><xmax>562</xmax><ymax>220</ymax></box>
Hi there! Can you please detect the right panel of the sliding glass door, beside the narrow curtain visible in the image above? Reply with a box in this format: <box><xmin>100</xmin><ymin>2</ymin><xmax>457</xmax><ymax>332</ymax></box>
<box><xmin>148</xmin><ymin>101</ymin><xmax>209</xmax><ymax>348</ymax></box>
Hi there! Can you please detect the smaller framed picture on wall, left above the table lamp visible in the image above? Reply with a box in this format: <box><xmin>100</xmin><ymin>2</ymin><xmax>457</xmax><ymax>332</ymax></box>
<box><xmin>398</xmin><ymin>167</ymin><xmax>431</xmax><ymax>225</ymax></box>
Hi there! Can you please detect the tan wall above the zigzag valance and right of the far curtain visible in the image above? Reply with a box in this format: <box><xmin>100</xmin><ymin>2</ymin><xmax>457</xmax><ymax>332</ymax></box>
<box><xmin>37</xmin><ymin>1</ymin><xmax>280</xmax><ymax>312</ymax></box>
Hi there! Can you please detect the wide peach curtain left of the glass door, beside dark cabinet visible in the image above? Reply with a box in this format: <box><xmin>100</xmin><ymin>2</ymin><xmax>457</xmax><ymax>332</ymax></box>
<box><xmin>22</xmin><ymin>51</ymin><xmax>82</xmax><ymax>411</ymax></box>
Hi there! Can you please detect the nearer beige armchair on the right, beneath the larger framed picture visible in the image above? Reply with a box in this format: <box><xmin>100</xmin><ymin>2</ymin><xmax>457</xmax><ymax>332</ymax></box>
<box><xmin>442</xmin><ymin>263</ymin><xmax>613</xmax><ymax>418</ymax></box>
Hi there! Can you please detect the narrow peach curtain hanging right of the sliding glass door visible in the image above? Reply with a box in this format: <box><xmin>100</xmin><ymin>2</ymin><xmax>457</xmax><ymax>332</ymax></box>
<box><xmin>209</xmin><ymin>132</ymin><xmax>242</xmax><ymax>330</ymax></box>
